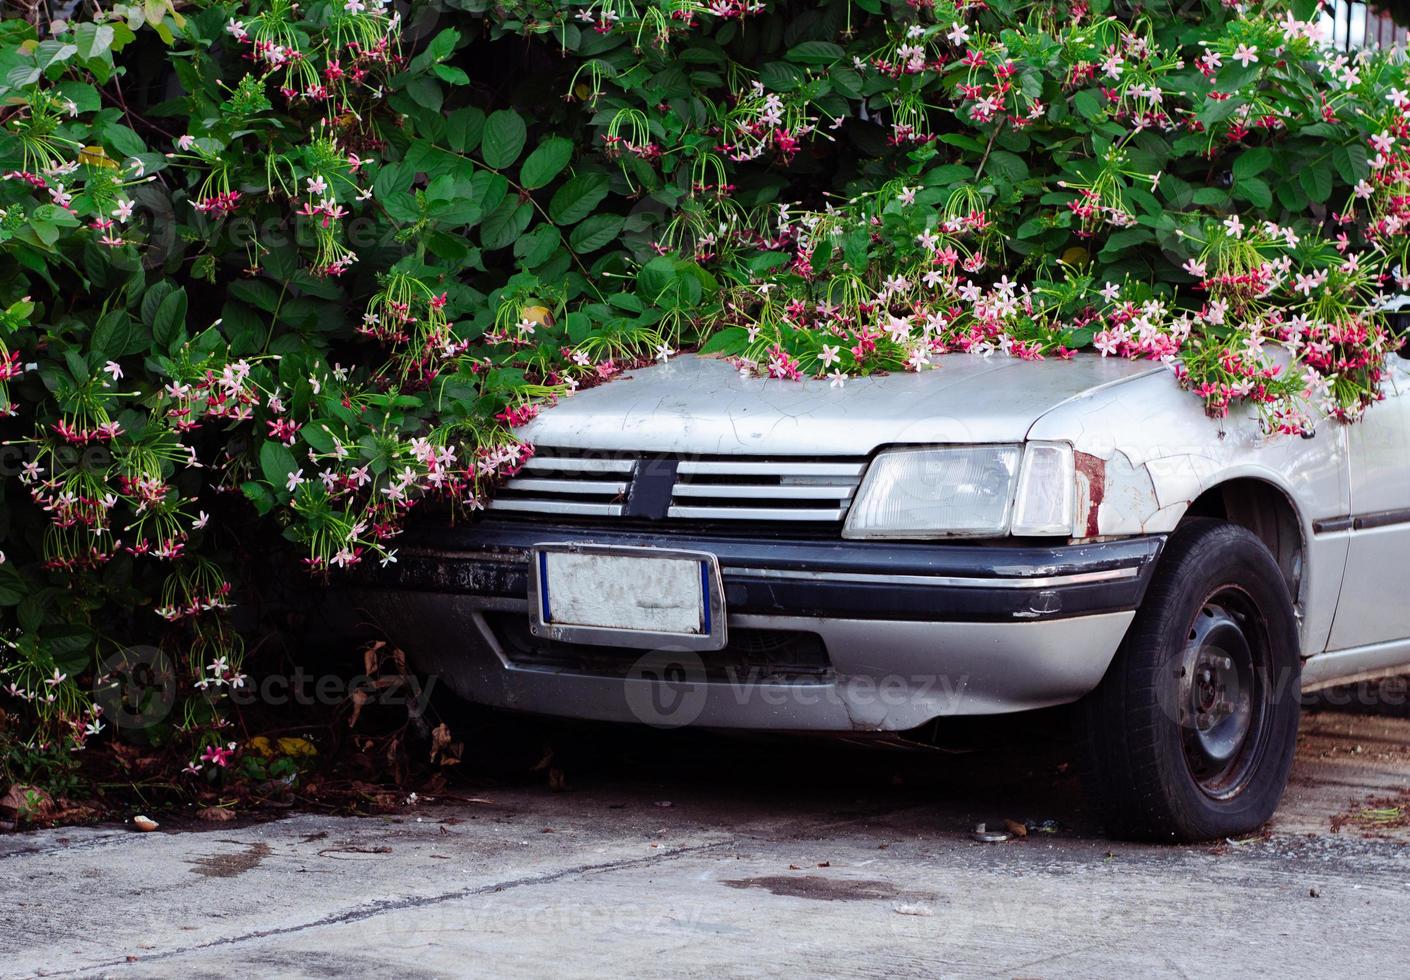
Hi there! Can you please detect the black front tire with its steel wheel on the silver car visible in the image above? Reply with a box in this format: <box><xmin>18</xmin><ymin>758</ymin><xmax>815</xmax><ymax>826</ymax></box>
<box><xmin>1081</xmin><ymin>517</ymin><xmax>1301</xmax><ymax>842</ymax></box>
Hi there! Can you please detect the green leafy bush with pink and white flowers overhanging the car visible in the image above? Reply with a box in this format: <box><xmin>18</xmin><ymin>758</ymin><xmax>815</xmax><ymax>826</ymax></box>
<box><xmin>0</xmin><ymin>0</ymin><xmax>1410</xmax><ymax>795</ymax></box>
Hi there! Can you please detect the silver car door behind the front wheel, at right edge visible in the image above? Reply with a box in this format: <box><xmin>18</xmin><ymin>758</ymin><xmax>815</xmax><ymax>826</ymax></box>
<box><xmin>1330</xmin><ymin>355</ymin><xmax>1410</xmax><ymax>650</ymax></box>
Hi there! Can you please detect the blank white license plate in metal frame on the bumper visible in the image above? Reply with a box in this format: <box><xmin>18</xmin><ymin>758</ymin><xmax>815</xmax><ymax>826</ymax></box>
<box><xmin>529</xmin><ymin>544</ymin><xmax>725</xmax><ymax>650</ymax></box>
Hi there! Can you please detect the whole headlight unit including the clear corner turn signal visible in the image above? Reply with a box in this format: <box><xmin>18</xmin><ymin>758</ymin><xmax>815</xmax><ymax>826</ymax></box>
<box><xmin>842</xmin><ymin>443</ymin><xmax>1076</xmax><ymax>537</ymax></box>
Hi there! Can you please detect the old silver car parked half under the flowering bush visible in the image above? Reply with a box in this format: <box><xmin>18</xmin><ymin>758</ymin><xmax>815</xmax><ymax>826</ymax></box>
<box><xmin>365</xmin><ymin>355</ymin><xmax>1410</xmax><ymax>840</ymax></box>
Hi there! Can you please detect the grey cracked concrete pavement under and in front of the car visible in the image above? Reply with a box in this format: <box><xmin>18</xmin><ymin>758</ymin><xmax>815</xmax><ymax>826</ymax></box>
<box><xmin>0</xmin><ymin>713</ymin><xmax>1410</xmax><ymax>980</ymax></box>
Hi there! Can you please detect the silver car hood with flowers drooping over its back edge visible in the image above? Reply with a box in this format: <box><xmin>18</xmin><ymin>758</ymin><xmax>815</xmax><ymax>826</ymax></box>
<box><xmin>519</xmin><ymin>354</ymin><xmax>1165</xmax><ymax>455</ymax></box>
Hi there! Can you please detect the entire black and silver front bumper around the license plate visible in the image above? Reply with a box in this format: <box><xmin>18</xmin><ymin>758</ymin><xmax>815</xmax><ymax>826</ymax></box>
<box><xmin>358</xmin><ymin>520</ymin><xmax>1165</xmax><ymax>732</ymax></box>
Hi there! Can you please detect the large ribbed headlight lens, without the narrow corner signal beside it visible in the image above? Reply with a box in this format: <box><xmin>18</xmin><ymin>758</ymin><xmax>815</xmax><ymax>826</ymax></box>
<box><xmin>843</xmin><ymin>446</ymin><xmax>1021</xmax><ymax>537</ymax></box>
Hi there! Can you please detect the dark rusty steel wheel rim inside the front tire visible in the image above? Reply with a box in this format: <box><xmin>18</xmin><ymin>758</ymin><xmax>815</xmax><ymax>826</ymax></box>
<box><xmin>1176</xmin><ymin>587</ymin><xmax>1272</xmax><ymax>800</ymax></box>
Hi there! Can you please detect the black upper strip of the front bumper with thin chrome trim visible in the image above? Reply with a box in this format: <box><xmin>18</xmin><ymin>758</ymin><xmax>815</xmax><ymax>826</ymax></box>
<box><xmin>365</xmin><ymin>520</ymin><xmax>1165</xmax><ymax>622</ymax></box>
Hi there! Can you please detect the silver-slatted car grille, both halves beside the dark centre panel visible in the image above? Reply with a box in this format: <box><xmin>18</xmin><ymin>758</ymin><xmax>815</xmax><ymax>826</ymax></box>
<box><xmin>489</xmin><ymin>446</ymin><xmax>866</xmax><ymax>523</ymax></box>
